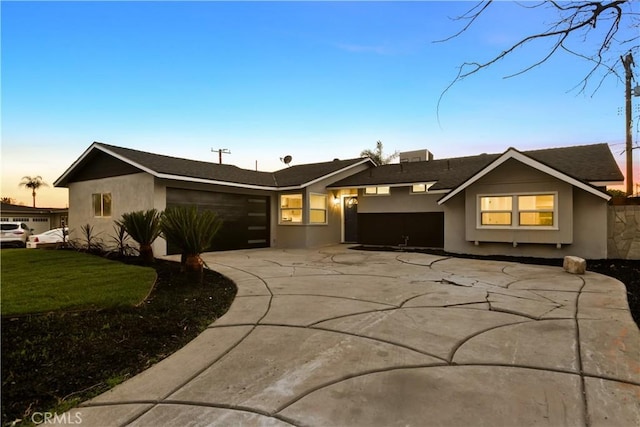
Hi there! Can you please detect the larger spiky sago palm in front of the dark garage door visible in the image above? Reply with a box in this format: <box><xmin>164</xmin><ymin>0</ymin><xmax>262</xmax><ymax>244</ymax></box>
<box><xmin>160</xmin><ymin>206</ymin><xmax>222</xmax><ymax>273</ymax></box>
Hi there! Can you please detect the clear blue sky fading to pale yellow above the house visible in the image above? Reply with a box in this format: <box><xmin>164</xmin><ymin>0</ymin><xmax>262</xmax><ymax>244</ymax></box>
<box><xmin>0</xmin><ymin>1</ymin><xmax>640</xmax><ymax>207</ymax></box>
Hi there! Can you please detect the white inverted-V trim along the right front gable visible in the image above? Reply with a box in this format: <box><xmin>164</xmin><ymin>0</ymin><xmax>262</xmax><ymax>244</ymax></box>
<box><xmin>438</xmin><ymin>148</ymin><xmax>611</xmax><ymax>205</ymax></box>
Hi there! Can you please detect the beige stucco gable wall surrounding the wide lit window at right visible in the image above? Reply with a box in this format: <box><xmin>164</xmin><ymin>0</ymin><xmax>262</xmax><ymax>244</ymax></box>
<box><xmin>445</xmin><ymin>161</ymin><xmax>607</xmax><ymax>259</ymax></box>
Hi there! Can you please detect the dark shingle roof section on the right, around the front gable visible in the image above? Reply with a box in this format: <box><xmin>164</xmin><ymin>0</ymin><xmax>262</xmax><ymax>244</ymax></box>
<box><xmin>330</xmin><ymin>144</ymin><xmax>624</xmax><ymax>190</ymax></box>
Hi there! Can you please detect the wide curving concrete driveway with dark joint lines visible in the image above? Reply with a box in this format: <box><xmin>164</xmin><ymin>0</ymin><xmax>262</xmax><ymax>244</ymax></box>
<box><xmin>71</xmin><ymin>246</ymin><xmax>640</xmax><ymax>426</ymax></box>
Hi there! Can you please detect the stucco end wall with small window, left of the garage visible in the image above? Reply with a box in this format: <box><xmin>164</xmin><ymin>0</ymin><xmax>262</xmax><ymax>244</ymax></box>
<box><xmin>69</xmin><ymin>173</ymin><xmax>156</xmax><ymax>245</ymax></box>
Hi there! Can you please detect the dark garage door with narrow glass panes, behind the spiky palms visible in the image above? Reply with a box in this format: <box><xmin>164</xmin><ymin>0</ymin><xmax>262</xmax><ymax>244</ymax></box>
<box><xmin>167</xmin><ymin>188</ymin><xmax>270</xmax><ymax>254</ymax></box>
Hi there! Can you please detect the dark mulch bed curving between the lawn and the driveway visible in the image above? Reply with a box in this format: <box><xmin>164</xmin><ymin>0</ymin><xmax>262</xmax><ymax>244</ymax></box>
<box><xmin>2</xmin><ymin>259</ymin><xmax>237</xmax><ymax>425</ymax></box>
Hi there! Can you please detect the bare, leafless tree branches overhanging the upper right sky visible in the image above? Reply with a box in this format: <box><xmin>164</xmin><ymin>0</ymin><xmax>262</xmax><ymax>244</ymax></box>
<box><xmin>438</xmin><ymin>0</ymin><xmax>640</xmax><ymax>92</ymax></box>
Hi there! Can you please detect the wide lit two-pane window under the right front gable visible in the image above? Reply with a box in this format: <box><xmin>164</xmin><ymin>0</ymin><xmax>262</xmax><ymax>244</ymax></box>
<box><xmin>478</xmin><ymin>193</ymin><xmax>558</xmax><ymax>229</ymax></box>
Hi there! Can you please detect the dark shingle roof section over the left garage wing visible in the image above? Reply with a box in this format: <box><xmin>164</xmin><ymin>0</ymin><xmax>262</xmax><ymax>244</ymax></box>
<box><xmin>55</xmin><ymin>142</ymin><xmax>366</xmax><ymax>189</ymax></box>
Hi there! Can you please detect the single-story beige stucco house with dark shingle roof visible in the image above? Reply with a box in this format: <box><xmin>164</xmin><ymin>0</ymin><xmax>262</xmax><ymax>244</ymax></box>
<box><xmin>55</xmin><ymin>142</ymin><xmax>624</xmax><ymax>259</ymax></box>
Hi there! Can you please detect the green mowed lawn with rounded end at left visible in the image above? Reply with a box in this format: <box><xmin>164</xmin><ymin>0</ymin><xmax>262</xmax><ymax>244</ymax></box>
<box><xmin>0</xmin><ymin>249</ymin><xmax>156</xmax><ymax>316</ymax></box>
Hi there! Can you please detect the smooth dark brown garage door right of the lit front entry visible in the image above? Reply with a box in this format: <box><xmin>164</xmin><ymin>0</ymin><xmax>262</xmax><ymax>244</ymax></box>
<box><xmin>358</xmin><ymin>212</ymin><xmax>444</xmax><ymax>248</ymax></box>
